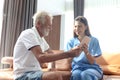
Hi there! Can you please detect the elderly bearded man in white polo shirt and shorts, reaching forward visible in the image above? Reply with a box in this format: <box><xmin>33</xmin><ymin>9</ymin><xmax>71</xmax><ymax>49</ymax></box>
<box><xmin>13</xmin><ymin>11</ymin><xmax>81</xmax><ymax>80</ymax></box>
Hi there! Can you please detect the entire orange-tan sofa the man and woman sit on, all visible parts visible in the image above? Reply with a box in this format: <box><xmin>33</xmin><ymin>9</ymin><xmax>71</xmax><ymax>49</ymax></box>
<box><xmin>0</xmin><ymin>50</ymin><xmax>120</xmax><ymax>80</ymax></box>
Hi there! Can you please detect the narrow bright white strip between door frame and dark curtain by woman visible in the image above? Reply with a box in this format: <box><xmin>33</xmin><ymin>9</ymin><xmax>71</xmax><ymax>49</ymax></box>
<box><xmin>63</xmin><ymin>0</ymin><xmax>74</xmax><ymax>49</ymax></box>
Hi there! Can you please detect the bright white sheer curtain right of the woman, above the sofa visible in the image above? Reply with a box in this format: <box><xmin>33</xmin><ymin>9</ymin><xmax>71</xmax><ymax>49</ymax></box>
<box><xmin>84</xmin><ymin>0</ymin><xmax>120</xmax><ymax>53</ymax></box>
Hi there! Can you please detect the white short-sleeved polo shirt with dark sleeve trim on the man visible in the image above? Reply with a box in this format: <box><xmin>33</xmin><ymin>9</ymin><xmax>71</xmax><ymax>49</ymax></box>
<box><xmin>13</xmin><ymin>27</ymin><xmax>49</xmax><ymax>79</ymax></box>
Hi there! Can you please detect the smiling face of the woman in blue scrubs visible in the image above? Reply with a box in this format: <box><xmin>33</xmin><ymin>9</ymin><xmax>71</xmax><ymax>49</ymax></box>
<box><xmin>74</xmin><ymin>21</ymin><xmax>86</xmax><ymax>36</ymax></box>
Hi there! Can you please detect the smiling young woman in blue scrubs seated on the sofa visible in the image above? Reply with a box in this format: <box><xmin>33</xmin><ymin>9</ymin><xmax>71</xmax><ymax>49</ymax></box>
<box><xmin>66</xmin><ymin>16</ymin><xmax>103</xmax><ymax>80</ymax></box>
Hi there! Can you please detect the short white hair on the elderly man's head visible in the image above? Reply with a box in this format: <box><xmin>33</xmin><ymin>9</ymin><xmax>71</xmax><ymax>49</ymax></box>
<box><xmin>32</xmin><ymin>11</ymin><xmax>53</xmax><ymax>25</ymax></box>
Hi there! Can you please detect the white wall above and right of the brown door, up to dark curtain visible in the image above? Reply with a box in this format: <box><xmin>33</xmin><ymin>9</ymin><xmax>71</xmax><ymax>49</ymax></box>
<box><xmin>37</xmin><ymin>0</ymin><xmax>73</xmax><ymax>50</ymax></box>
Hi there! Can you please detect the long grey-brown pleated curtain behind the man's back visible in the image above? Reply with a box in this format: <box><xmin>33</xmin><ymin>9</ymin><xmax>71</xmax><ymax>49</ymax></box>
<box><xmin>0</xmin><ymin>0</ymin><xmax>37</xmax><ymax>68</ymax></box>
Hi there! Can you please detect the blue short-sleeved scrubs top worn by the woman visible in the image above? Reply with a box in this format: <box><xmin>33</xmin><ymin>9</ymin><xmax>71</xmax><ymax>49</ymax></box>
<box><xmin>65</xmin><ymin>37</ymin><xmax>102</xmax><ymax>73</ymax></box>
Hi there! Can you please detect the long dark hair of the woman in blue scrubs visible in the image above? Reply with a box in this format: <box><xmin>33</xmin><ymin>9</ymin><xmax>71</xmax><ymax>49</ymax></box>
<box><xmin>74</xmin><ymin>16</ymin><xmax>91</xmax><ymax>37</ymax></box>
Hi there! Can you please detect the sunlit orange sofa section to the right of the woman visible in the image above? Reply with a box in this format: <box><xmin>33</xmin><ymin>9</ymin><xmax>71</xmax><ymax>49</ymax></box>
<box><xmin>96</xmin><ymin>52</ymin><xmax>120</xmax><ymax>80</ymax></box>
